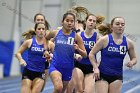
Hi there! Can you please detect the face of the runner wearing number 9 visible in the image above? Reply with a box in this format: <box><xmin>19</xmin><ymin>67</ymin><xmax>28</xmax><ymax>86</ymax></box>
<box><xmin>86</xmin><ymin>15</ymin><xmax>96</xmax><ymax>30</ymax></box>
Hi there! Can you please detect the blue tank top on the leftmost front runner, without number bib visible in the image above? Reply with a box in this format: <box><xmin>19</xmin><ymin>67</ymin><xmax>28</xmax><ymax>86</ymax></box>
<box><xmin>26</xmin><ymin>37</ymin><xmax>46</xmax><ymax>72</ymax></box>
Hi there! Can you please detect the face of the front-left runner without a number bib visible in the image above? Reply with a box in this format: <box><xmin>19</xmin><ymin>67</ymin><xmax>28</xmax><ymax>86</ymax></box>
<box><xmin>36</xmin><ymin>24</ymin><xmax>46</xmax><ymax>38</ymax></box>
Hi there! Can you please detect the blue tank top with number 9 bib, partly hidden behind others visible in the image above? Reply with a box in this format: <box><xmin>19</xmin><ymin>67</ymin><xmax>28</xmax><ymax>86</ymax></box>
<box><xmin>80</xmin><ymin>32</ymin><xmax>97</xmax><ymax>65</ymax></box>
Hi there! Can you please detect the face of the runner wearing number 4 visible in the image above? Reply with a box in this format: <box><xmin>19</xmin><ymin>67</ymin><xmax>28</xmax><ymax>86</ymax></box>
<box><xmin>112</xmin><ymin>18</ymin><xmax>125</xmax><ymax>34</ymax></box>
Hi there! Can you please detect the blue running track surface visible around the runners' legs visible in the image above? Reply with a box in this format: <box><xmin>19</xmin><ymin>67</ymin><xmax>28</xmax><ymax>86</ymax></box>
<box><xmin>0</xmin><ymin>70</ymin><xmax>140</xmax><ymax>93</ymax></box>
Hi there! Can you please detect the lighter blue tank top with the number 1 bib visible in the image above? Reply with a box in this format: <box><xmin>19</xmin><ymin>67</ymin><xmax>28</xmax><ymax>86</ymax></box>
<box><xmin>52</xmin><ymin>29</ymin><xmax>75</xmax><ymax>68</ymax></box>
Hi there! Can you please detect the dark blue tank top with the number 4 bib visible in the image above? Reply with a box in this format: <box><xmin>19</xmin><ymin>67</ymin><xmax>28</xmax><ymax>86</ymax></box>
<box><xmin>99</xmin><ymin>34</ymin><xmax>128</xmax><ymax>76</ymax></box>
